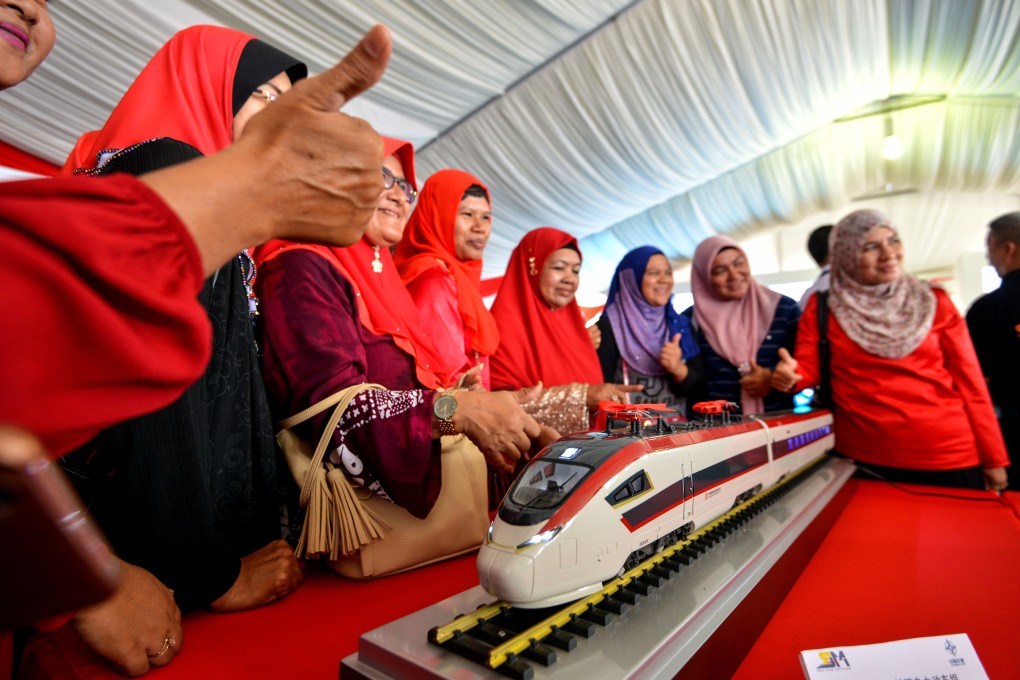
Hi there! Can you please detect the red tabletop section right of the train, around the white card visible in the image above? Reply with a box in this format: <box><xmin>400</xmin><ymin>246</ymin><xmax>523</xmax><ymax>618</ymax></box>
<box><xmin>733</xmin><ymin>482</ymin><xmax>1020</xmax><ymax>680</ymax></box>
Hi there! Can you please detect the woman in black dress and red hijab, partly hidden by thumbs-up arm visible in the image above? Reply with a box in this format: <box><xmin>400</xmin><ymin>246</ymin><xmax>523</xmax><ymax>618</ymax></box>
<box><xmin>56</xmin><ymin>27</ymin><xmax>306</xmax><ymax>623</ymax></box>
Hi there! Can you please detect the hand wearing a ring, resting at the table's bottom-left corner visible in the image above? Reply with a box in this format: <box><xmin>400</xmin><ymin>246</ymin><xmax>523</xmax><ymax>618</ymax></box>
<box><xmin>71</xmin><ymin>561</ymin><xmax>184</xmax><ymax>676</ymax></box>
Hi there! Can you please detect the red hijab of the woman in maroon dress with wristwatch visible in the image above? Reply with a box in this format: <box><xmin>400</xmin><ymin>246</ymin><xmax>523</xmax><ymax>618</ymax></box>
<box><xmin>255</xmin><ymin>137</ymin><xmax>453</xmax><ymax>389</ymax></box>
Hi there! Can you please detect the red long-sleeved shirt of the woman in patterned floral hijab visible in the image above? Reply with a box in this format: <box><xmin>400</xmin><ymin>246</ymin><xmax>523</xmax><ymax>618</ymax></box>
<box><xmin>795</xmin><ymin>289</ymin><xmax>1009</xmax><ymax>470</ymax></box>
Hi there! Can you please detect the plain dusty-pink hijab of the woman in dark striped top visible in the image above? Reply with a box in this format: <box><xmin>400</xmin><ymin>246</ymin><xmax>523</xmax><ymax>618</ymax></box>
<box><xmin>691</xmin><ymin>237</ymin><xmax>781</xmax><ymax>413</ymax></box>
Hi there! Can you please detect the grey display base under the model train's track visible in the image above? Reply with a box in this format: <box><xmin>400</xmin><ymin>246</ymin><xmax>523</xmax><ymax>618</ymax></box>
<box><xmin>340</xmin><ymin>459</ymin><xmax>856</xmax><ymax>680</ymax></box>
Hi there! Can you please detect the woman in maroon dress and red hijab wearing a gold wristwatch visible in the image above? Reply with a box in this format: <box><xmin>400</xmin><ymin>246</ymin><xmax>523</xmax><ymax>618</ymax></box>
<box><xmin>256</xmin><ymin>138</ymin><xmax>542</xmax><ymax>518</ymax></box>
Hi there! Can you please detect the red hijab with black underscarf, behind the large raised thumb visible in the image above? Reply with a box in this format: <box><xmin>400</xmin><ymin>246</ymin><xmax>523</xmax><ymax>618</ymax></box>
<box><xmin>62</xmin><ymin>25</ymin><xmax>307</xmax><ymax>174</ymax></box>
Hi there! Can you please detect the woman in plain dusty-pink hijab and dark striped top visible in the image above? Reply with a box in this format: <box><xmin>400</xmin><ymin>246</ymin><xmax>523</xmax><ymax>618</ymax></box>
<box><xmin>683</xmin><ymin>237</ymin><xmax>801</xmax><ymax>414</ymax></box>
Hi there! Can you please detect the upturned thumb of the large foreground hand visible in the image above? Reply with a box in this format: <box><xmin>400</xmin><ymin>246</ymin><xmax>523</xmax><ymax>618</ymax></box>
<box><xmin>295</xmin><ymin>23</ymin><xmax>393</xmax><ymax>111</ymax></box>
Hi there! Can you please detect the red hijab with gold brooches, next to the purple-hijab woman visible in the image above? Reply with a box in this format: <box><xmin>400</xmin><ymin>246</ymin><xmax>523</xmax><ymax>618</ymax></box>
<box><xmin>492</xmin><ymin>226</ymin><xmax>603</xmax><ymax>389</ymax></box>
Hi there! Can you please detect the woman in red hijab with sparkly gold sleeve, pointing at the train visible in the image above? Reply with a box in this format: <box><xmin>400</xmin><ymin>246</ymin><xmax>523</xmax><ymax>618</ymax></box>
<box><xmin>492</xmin><ymin>226</ymin><xmax>642</xmax><ymax>434</ymax></box>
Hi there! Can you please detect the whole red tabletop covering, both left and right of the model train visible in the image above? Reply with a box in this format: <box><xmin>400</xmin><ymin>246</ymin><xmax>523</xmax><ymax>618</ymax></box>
<box><xmin>22</xmin><ymin>482</ymin><xmax>1020</xmax><ymax>680</ymax></box>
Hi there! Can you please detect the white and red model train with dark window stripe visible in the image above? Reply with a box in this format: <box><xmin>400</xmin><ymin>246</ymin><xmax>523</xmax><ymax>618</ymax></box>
<box><xmin>478</xmin><ymin>405</ymin><xmax>833</xmax><ymax>608</ymax></box>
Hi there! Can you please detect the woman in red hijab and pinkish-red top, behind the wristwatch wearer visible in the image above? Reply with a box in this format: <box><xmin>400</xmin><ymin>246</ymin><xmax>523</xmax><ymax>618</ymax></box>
<box><xmin>394</xmin><ymin>169</ymin><xmax>500</xmax><ymax>389</ymax></box>
